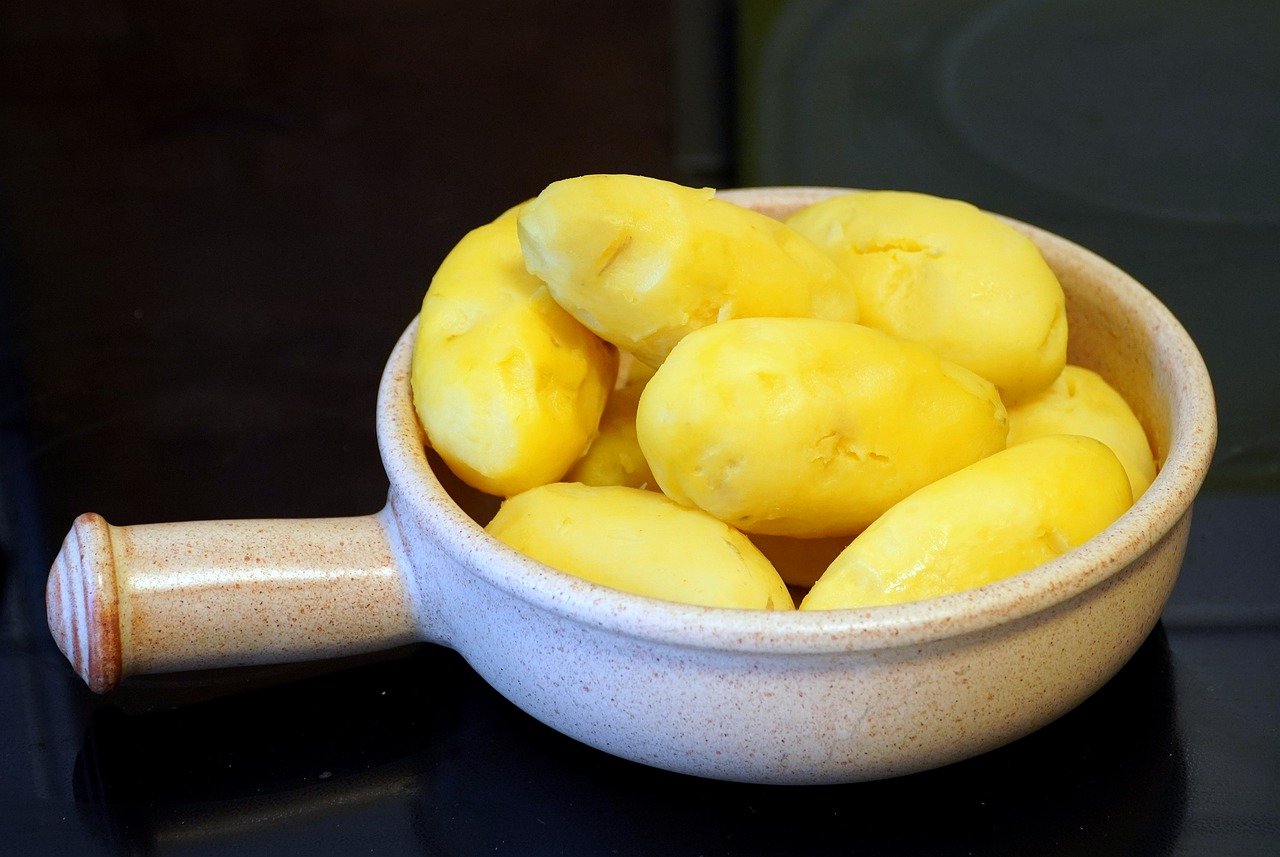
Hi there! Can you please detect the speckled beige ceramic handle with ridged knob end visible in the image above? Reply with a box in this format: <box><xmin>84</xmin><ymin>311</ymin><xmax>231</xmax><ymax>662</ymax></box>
<box><xmin>45</xmin><ymin>509</ymin><xmax>424</xmax><ymax>693</ymax></box>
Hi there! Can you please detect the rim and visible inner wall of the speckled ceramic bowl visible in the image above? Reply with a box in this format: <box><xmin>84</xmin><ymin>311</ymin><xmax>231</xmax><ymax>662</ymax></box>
<box><xmin>379</xmin><ymin>188</ymin><xmax>1216</xmax><ymax>650</ymax></box>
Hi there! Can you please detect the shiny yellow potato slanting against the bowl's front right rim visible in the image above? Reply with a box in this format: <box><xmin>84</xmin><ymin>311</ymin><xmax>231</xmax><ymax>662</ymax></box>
<box><xmin>800</xmin><ymin>435</ymin><xmax>1132</xmax><ymax>610</ymax></box>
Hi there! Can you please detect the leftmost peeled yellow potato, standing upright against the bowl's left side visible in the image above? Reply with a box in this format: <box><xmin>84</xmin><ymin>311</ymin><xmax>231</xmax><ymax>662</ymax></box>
<box><xmin>411</xmin><ymin>210</ymin><xmax>617</xmax><ymax>496</ymax></box>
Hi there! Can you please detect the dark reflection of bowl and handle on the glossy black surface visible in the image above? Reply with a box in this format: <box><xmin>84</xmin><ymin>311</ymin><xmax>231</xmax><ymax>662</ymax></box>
<box><xmin>64</xmin><ymin>632</ymin><xmax>1187</xmax><ymax>854</ymax></box>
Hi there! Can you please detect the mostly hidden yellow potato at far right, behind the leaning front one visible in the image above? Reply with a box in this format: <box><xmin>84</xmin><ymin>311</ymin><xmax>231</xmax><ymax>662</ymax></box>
<box><xmin>1009</xmin><ymin>366</ymin><xmax>1156</xmax><ymax>499</ymax></box>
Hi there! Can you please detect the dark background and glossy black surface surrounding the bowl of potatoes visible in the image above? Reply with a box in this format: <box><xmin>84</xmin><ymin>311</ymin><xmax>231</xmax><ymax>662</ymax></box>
<box><xmin>0</xmin><ymin>0</ymin><xmax>1280</xmax><ymax>854</ymax></box>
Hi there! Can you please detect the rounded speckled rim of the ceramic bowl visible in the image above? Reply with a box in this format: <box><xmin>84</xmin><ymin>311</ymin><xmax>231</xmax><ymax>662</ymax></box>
<box><xmin>376</xmin><ymin>187</ymin><xmax>1217</xmax><ymax>654</ymax></box>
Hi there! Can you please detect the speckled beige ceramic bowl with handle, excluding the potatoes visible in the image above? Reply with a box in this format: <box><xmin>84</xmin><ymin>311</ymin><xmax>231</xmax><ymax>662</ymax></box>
<box><xmin>49</xmin><ymin>188</ymin><xmax>1216</xmax><ymax>783</ymax></box>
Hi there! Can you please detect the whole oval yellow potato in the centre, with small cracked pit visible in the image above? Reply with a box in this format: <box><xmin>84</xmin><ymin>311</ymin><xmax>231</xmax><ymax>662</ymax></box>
<box><xmin>636</xmin><ymin>318</ymin><xmax>1007</xmax><ymax>537</ymax></box>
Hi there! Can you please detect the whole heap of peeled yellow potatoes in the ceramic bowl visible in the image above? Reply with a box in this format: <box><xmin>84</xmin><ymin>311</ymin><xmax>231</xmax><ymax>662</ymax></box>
<box><xmin>412</xmin><ymin>175</ymin><xmax>1156</xmax><ymax>610</ymax></box>
